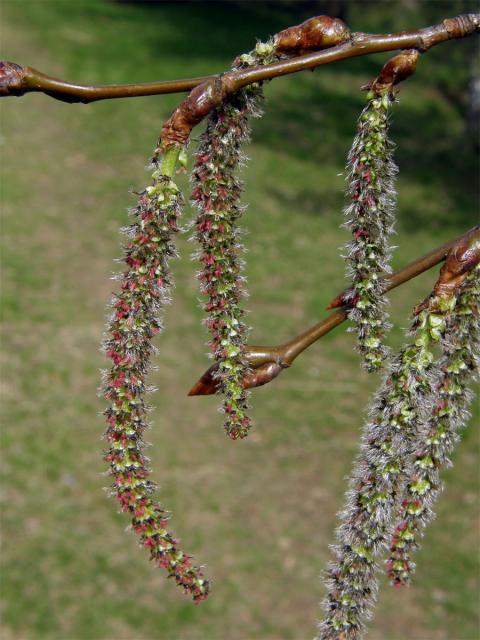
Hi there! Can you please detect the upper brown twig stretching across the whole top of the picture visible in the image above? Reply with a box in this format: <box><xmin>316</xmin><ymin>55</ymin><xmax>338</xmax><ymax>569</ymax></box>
<box><xmin>0</xmin><ymin>13</ymin><xmax>480</xmax><ymax>103</ymax></box>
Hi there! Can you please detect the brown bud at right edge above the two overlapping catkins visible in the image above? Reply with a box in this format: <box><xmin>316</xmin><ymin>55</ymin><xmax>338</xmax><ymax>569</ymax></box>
<box><xmin>413</xmin><ymin>226</ymin><xmax>480</xmax><ymax>315</ymax></box>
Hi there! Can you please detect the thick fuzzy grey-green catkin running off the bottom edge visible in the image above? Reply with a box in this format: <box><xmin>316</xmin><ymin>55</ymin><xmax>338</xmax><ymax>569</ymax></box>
<box><xmin>317</xmin><ymin>298</ymin><xmax>460</xmax><ymax>640</ymax></box>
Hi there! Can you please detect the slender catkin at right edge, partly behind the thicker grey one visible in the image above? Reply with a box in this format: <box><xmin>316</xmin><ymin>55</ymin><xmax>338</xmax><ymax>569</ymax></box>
<box><xmin>387</xmin><ymin>266</ymin><xmax>480</xmax><ymax>586</ymax></box>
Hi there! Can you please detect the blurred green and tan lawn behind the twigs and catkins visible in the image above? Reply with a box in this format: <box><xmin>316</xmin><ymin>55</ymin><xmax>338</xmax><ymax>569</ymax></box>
<box><xmin>1</xmin><ymin>0</ymin><xmax>479</xmax><ymax>640</ymax></box>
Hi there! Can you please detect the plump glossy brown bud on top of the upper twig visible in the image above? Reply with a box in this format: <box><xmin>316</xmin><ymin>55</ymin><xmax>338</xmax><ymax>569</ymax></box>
<box><xmin>274</xmin><ymin>16</ymin><xmax>350</xmax><ymax>55</ymax></box>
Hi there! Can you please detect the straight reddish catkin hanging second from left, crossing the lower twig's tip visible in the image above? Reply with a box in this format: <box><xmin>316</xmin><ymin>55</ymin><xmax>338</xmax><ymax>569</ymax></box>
<box><xmin>192</xmin><ymin>43</ymin><xmax>276</xmax><ymax>440</ymax></box>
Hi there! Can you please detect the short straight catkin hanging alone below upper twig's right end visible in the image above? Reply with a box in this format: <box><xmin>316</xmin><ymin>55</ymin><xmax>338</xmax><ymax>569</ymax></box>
<box><xmin>344</xmin><ymin>91</ymin><xmax>398</xmax><ymax>371</ymax></box>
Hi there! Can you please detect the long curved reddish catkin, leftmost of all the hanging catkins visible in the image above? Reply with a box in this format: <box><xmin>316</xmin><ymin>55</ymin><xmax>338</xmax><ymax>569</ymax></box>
<box><xmin>103</xmin><ymin>150</ymin><xmax>209</xmax><ymax>602</ymax></box>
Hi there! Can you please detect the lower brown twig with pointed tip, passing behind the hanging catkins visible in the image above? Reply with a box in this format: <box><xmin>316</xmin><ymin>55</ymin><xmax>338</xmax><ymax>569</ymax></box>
<box><xmin>188</xmin><ymin>225</ymin><xmax>480</xmax><ymax>396</ymax></box>
